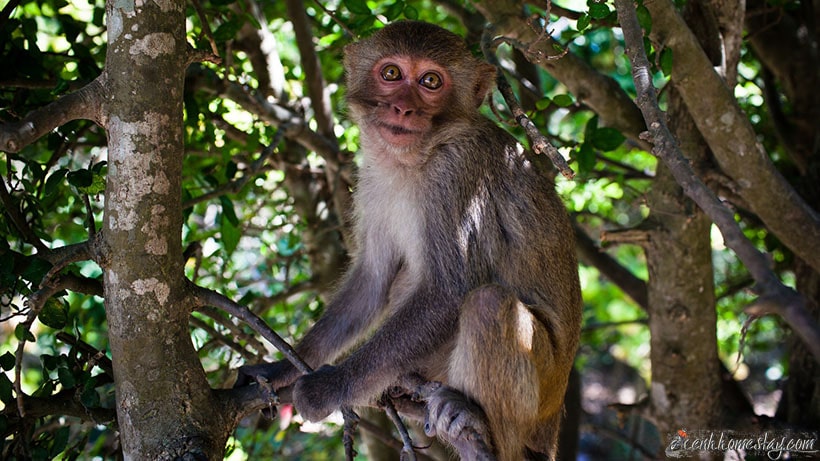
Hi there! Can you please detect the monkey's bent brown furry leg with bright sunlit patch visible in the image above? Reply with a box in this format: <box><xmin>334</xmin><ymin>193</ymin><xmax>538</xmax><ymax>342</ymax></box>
<box><xmin>447</xmin><ymin>285</ymin><xmax>555</xmax><ymax>461</ymax></box>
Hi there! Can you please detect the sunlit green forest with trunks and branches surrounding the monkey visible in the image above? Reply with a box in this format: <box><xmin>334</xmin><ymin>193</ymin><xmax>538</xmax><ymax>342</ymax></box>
<box><xmin>0</xmin><ymin>0</ymin><xmax>820</xmax><ymax>459</ymax></box>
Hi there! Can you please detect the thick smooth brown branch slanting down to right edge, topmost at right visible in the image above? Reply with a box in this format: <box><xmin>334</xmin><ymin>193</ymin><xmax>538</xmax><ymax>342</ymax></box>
<box><xmin>644</xmin><ymin>0</ymin><xmax>820</xmax><ymax>274</ymax></box>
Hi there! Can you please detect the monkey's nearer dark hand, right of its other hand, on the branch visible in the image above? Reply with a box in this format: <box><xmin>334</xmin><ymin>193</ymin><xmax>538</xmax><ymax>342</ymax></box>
<box><xmin>293</xmin><ymin>365</ymin><xmax>346</xmax><ymax>422</ymax></box>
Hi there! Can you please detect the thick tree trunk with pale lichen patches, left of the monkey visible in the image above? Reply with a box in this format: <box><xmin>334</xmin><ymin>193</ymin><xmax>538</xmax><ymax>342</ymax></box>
<box><xmin>102</xmin><ymin>0</ymin><xmax>230</xmax><ymax>454</ymax></box>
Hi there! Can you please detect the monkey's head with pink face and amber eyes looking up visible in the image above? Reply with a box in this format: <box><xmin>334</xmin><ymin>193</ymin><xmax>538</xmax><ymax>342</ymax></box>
<box><xmin>344</xmin><ymin>21</ymin><xmax>495</xmax><ymax>152</ymax></box>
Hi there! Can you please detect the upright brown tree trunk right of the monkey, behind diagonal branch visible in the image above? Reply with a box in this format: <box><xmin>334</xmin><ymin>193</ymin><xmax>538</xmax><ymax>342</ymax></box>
<box><xmin>646</xmin><ymin>85</ymin><xmax>721</xmax><ymax>447</ymax></box>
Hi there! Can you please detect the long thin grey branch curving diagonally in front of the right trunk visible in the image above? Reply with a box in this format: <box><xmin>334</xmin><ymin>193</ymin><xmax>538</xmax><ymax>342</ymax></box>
<box><xmin>615</xmin><ymin>0</ymin><xmax>820</xmax><ymax>362</ymax></box>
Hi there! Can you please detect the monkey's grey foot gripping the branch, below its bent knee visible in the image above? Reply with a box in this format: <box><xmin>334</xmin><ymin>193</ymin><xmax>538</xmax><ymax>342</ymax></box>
<box><xmin>424</xmin><ymin>386</ymin><xmax>492</xmax><ymax>452</ymax></box>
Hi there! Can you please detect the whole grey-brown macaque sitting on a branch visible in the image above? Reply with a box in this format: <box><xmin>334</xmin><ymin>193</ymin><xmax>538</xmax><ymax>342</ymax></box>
<box><xmin>239</xmin><ymin>21</ymin><xmax>581</xmax><ymax>461</ymax></box>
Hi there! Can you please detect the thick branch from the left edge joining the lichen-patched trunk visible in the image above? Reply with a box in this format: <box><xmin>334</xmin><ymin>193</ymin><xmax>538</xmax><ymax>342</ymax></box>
<box><xmin>0</xmin><ymin>73</ymin><xmax>106</xmax><ymax>152</ymax></box>
